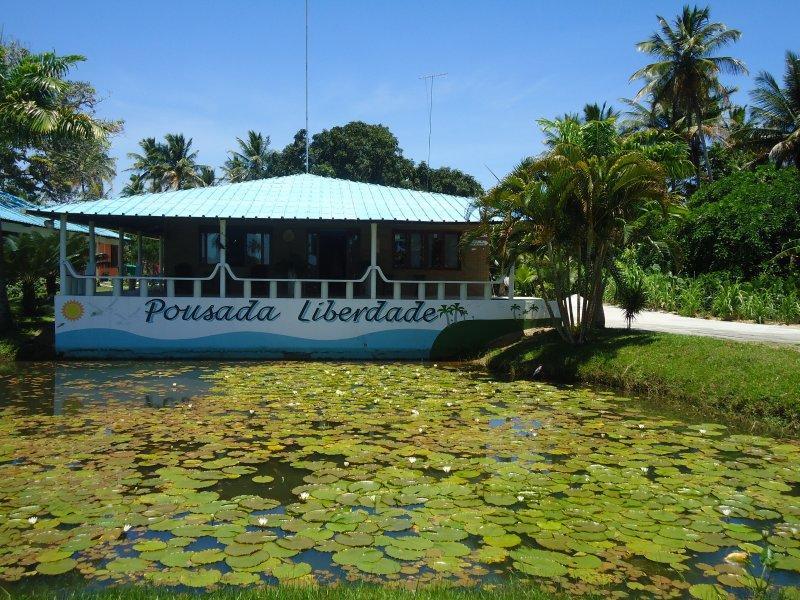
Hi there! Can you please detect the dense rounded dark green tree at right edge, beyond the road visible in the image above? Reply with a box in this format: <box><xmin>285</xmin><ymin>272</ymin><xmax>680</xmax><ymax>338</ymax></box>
<box><xmin>673</xmin><ymin>165</ymin><xmax>800</xmax><ymax>277</ymax></box>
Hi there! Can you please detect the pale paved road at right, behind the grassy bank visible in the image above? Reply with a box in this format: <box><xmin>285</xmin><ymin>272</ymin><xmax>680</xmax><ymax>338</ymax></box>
<box><xmin>605</xmin><ymin>306</ymin><xmax>800</xmax><ymax>345</ymax></box>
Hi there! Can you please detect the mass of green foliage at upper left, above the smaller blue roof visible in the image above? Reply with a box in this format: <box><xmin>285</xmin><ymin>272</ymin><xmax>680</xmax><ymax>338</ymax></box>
<box><xmin>0</xmin><ymin>43</ymin><xmax>121</xmax><ymax>201</ymax></box>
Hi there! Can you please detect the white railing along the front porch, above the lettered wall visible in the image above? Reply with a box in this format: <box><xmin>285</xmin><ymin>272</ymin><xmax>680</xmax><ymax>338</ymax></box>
<box><xmin>61</xmin><ymin>261</ymin><xmax>513</xmax><ymax>300</ymax></box>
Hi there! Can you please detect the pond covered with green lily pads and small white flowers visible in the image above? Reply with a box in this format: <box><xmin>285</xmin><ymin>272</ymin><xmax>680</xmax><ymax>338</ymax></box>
<box><xmin>0</xmin><ymin>362</ymin><xmax>800</xmax><ymax>597</ymax></box>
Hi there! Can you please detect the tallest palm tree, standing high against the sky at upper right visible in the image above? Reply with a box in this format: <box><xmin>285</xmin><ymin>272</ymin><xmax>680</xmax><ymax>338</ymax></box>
<box><xmin>631</xmin><ymin>5</ymin><xmax>747</xmax><ymax>178</ymax></box>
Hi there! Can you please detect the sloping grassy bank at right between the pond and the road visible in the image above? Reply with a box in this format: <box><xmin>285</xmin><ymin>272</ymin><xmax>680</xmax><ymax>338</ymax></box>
<box><xmin>485</xmin><ymin>330</ymin><xmax>800</xmax><ymax>433</ymax></box>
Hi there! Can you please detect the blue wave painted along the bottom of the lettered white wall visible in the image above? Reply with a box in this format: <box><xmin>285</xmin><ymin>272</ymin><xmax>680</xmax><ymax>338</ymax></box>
<box><xmin>56</xmin><ymin>328</ymin><xmax>439</xmax><ymax>359</ymax></box>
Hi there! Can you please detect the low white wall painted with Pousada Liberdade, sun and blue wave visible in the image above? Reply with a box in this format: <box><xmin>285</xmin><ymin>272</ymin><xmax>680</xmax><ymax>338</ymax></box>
<box><xmin>56</xmin><ymin>297</ymin><xmax>547</xmax><ymax>359</ymax></box>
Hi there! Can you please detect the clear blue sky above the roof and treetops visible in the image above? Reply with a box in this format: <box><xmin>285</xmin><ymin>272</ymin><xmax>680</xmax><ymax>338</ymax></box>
<box><xmin>6</xmin><ymin>0</ymin><xmax>800</xmax><ymax>191</ymax></box>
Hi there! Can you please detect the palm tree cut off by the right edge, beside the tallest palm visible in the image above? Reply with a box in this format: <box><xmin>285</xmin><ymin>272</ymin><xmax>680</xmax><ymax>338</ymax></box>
<box><xmin>749</xmin><ymin>52</ymin><xmax>800</xmax><ymax>168</ymax></box>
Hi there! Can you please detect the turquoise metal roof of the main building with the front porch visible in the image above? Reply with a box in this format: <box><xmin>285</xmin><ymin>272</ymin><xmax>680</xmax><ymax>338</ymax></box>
<box><xmin>29</xmin><ymin>174</ymin><xmax>479</xmax><ymax>223</ymax></box>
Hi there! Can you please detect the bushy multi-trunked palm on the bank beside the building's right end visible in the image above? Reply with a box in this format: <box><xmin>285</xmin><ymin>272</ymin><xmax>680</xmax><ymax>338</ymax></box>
<box><xmin>479</xmin><ymin>119</ymin><xmax>687</xmax><ymax>343</ymax></box>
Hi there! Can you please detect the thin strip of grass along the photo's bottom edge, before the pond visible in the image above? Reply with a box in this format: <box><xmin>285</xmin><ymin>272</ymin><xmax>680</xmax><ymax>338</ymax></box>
<box><xmin>0</xmin><ymin>583</ymin><xmax>571</xmax><ymax>600</ymax></box>
